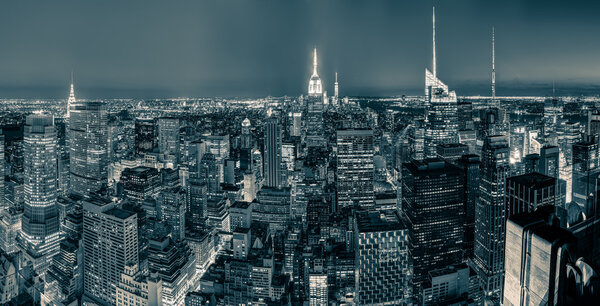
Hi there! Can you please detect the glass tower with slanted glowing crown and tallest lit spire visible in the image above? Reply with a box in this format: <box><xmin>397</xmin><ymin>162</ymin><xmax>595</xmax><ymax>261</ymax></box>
<box><xmin>425</xmin><ymin>7</ymin><xmax>458</xmax><ymax>157</ymax></box>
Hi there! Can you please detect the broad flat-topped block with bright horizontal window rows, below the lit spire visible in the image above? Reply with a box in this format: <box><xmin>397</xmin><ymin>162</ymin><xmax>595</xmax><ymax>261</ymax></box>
<box><xmin>336</xmin><ymin>129</ymin><xmax>374</xmax><ymax>208</ymax></box>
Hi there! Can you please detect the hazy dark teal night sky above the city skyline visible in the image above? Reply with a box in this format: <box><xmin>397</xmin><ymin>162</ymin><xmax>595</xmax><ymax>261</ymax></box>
<box><xmin>0</xmin><ymin>0</ymin><xmax>600</xmax><ymax>98</ymax></box>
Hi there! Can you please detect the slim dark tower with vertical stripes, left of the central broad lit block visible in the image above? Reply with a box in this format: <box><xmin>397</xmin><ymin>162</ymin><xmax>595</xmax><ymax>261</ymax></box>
<box><xmin>264</xmin><ymin>117</ymin><xmax>283</xmax><ymax>188</ymax></box>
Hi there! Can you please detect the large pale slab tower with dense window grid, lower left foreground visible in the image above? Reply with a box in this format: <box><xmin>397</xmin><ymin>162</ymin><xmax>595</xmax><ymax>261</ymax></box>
<box><xmin>83</xmin><ymin>198</ymin><xmax>139</xmax><ymax>305</ymax></box>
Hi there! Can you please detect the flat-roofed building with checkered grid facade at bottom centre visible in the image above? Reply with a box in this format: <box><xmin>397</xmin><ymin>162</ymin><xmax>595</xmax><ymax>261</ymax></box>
<box><xmin>354</xmin><ymin>210</ymin><xmax>413</xmax><ymax>305</ymax></box>
